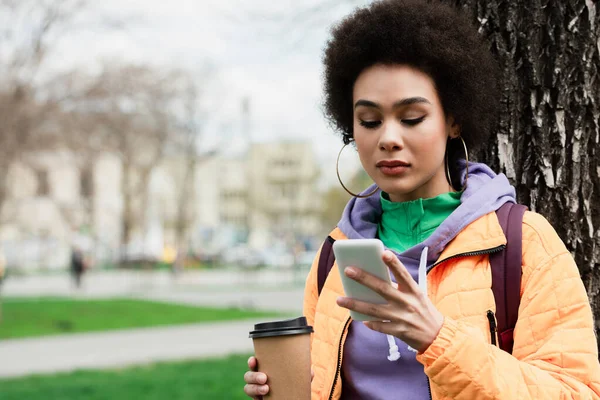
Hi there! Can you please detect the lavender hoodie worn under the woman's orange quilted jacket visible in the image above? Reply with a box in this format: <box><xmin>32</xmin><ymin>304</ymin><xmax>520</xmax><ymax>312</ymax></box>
<box><xmin>338</xmin><ymin>163</ymin><xmax>515</xmax><ymax>400</ymax></box>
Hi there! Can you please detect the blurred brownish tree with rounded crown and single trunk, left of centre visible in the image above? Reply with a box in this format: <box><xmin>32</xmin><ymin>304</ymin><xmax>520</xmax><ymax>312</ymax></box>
<box><xmin>75</xmin><ymin>64</ymin><xmax>183</xmax><ymax>264</ymax></box>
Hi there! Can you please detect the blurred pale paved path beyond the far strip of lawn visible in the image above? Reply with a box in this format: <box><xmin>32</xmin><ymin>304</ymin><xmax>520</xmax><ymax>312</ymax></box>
<box><xmin>0</xmin><ymin>271</ymin><xmax>304</xmax><ymax>313</ymax></box>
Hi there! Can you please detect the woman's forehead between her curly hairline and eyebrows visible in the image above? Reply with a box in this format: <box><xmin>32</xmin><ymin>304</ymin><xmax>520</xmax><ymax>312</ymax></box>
<box><xmin>353</xmin><ymin>65</ymin><xmax>437</xmax><ymax>104</ymax></box>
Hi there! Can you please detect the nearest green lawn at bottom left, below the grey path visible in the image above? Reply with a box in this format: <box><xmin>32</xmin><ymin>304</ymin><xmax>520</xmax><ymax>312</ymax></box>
<box><xmin>0</xmin><ymin>355</ymin><xmax>249</xmax><ymax>400</ymax></box>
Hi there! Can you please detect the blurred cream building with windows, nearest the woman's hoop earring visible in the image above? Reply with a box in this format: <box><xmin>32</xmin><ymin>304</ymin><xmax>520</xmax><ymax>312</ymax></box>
<box><xmin>196</xmin><ymin>142</ymin><xmax>321</xmax><ymax>252</ymax></box>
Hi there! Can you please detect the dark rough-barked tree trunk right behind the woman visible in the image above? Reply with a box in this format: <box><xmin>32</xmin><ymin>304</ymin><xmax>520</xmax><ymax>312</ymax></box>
<box><xmin>455</xmin><ymin>0</ymin><xmax>600</xmax><ymax>347</ymax></box>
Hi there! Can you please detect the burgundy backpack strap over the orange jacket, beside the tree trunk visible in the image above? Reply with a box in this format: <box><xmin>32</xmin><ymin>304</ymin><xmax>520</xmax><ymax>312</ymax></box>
<box><xmin>490</xmin><ymin>203</ymin><xmax>527</xmax><ymax>353</ymax></box>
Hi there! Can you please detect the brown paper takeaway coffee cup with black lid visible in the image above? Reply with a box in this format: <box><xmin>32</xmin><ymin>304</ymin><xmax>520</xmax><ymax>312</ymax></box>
<box><xmin>250</xmin><ymin>317</ymin><xmax>313</xmax><ymax>400</ymax></box>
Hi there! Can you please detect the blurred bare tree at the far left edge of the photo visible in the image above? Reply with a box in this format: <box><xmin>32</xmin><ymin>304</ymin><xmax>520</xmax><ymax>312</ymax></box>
<box><xmin>0</xmin><ymin>0</ymin><xmax>84</xmax><ymax>227</ymax></box>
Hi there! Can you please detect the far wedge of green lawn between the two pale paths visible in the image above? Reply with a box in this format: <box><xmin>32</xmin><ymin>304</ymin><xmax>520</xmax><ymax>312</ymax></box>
<box><xmin>0</xmin><ymin>298</ymin><xmax>282</xmax><ymax>339</ymax></box>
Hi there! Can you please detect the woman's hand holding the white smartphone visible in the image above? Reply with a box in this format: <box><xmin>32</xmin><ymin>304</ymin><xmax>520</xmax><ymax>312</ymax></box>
<box><xmin>337</xmin><ymin>250</ymin><xmax>444</xmax><ymax>353</ymax></box>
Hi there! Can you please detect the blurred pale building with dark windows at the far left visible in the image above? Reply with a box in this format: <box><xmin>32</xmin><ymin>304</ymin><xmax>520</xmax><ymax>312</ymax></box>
<box><xmin>0</xmin><ymin>151</ymin><xmax>121</xmax><ymax>269</ymax></box>
